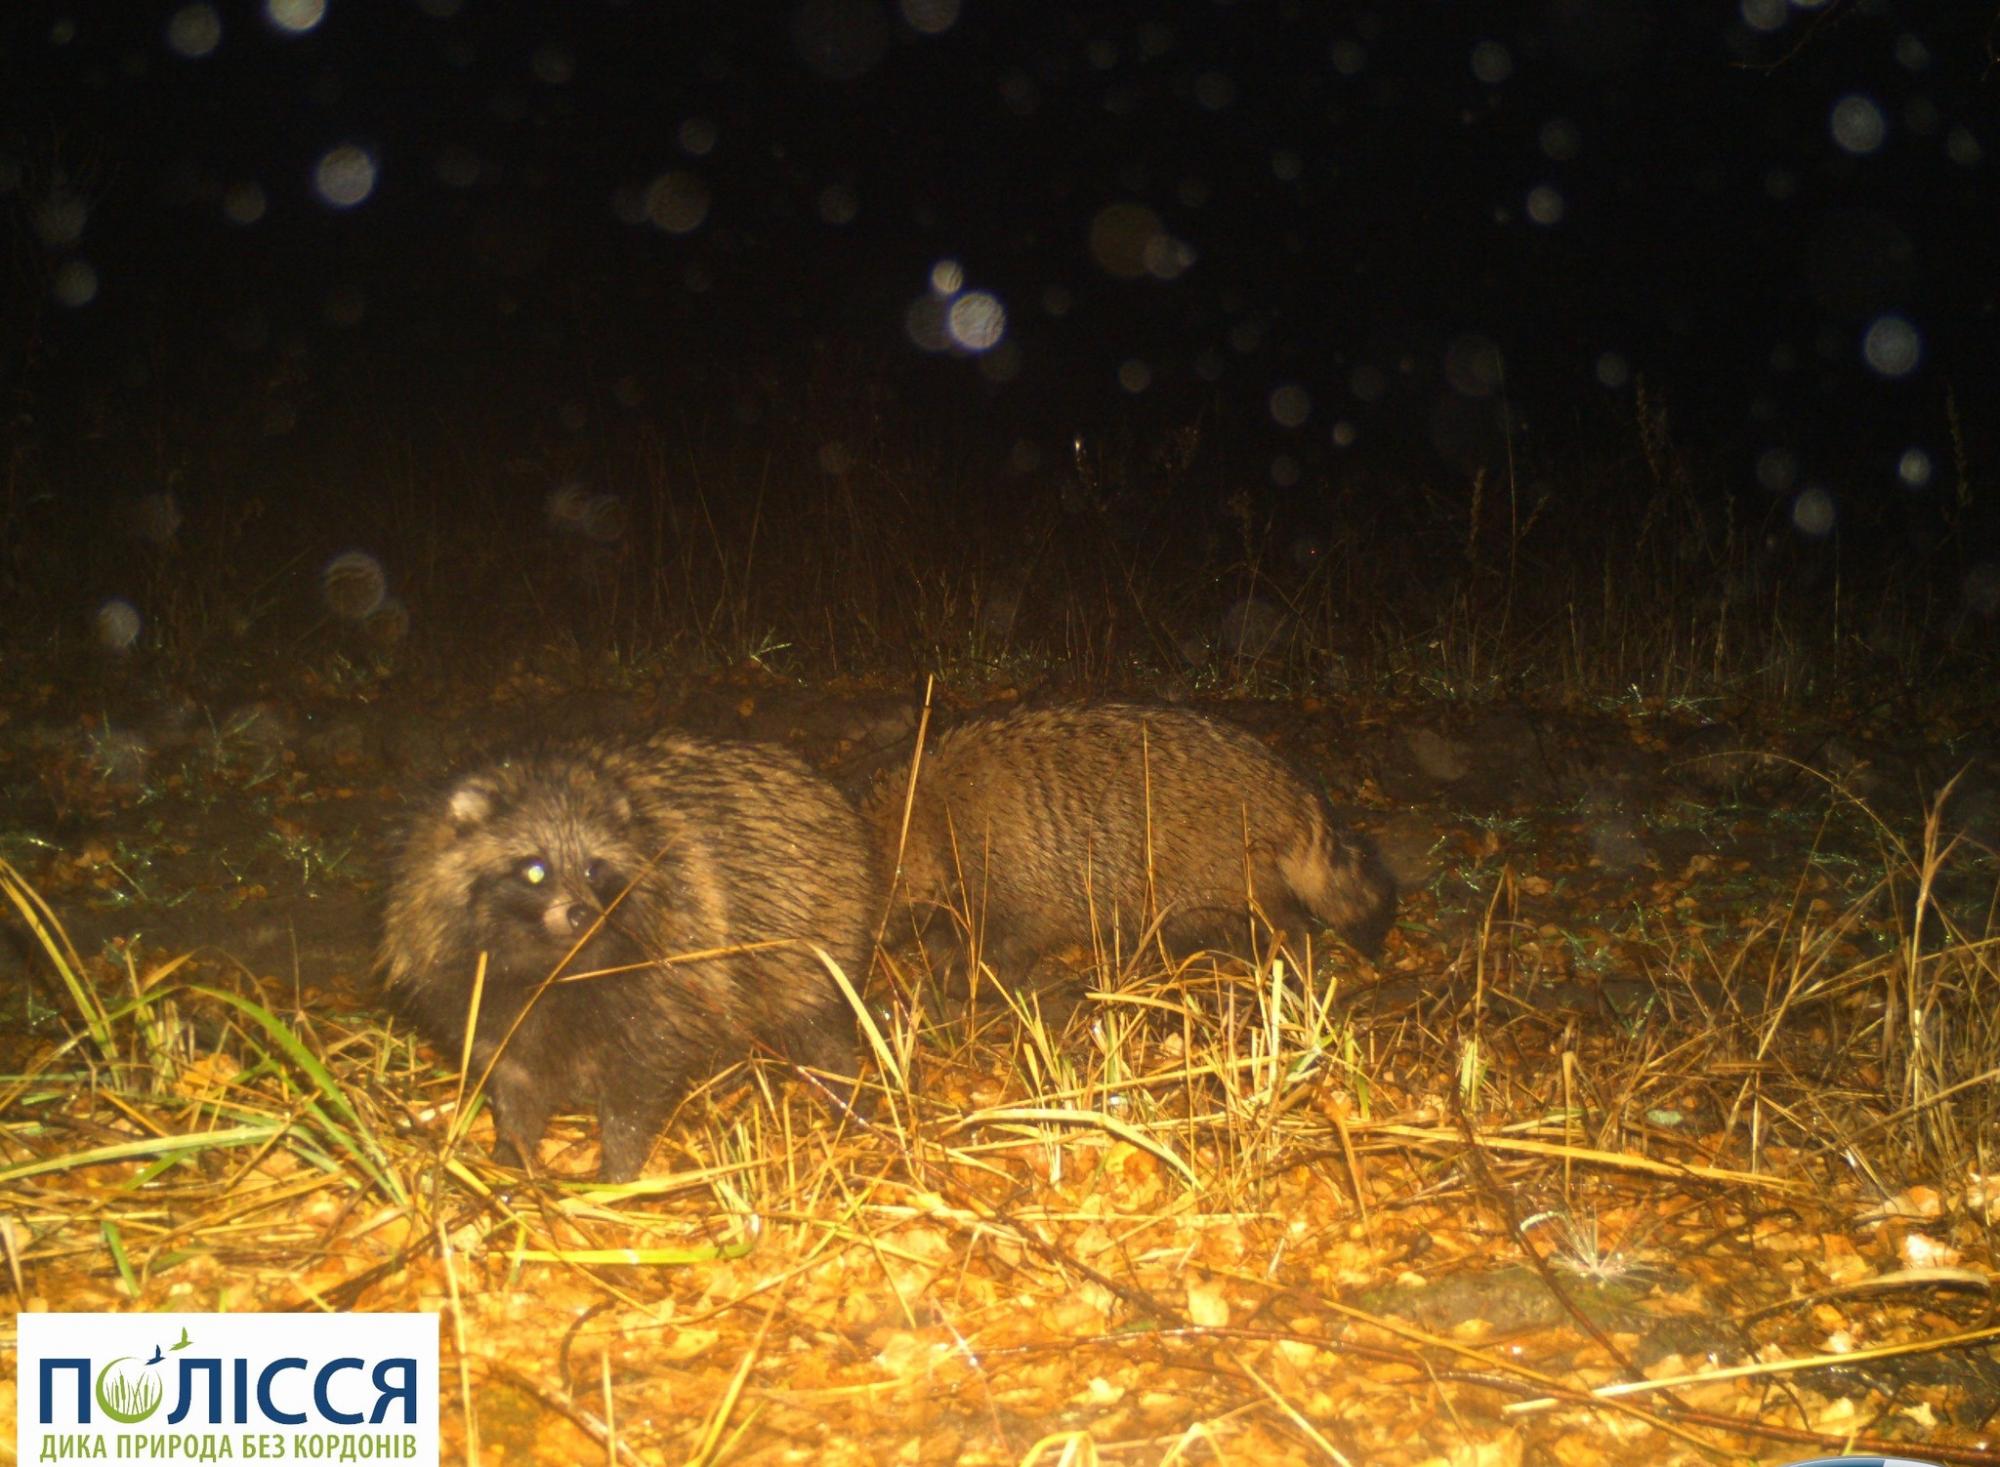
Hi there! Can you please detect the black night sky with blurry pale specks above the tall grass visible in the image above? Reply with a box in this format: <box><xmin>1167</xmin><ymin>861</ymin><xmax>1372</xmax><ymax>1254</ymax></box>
<box><xmin>0</xmin><ymin>0</ymin><xmax>2000</xmax><ymax>499</ymax></box>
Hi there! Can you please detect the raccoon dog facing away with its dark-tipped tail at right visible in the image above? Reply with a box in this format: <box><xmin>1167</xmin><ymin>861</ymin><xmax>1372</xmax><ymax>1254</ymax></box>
<box><xmin>862</xmin><ymin>704</ymin><xmax>1396</xmax><ymax>977</ymax></box>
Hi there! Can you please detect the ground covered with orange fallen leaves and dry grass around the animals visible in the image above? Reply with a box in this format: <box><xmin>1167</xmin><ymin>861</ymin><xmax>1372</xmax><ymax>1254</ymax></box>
<box><xmin>0</xmin><ymin>676</ymin><xmax>2000</xmax><ymax>1463</ymax></box>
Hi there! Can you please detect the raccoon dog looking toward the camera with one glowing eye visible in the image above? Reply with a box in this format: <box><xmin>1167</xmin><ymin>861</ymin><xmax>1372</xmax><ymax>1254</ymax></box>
<box><xmin>382</xmin><ymin>734</ymin><xmax>880</xmax><ymax>1181</ymax></box>
